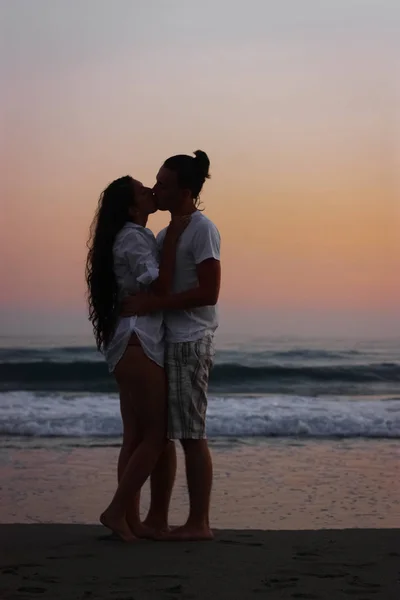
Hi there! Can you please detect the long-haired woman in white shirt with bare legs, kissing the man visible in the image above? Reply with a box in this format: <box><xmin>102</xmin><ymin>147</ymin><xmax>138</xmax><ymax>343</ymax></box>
<box><xmin>86</xmin><ymin>176</ymin><xmax>189</xmax><ymax>541</ymax></box>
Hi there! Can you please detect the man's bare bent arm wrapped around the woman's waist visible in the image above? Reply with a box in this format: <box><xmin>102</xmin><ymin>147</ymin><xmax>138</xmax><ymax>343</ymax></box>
<box><xmin>122</xmin><ymin>258</ymin><xmax>221</xmax><ymax>316</ymax></box>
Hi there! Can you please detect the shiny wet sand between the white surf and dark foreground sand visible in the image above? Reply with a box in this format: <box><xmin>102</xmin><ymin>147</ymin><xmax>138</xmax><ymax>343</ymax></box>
<box><xmin>0</xmin><ymin>439</ymin><xmax>400</xmax><ymax>528</ymax></box>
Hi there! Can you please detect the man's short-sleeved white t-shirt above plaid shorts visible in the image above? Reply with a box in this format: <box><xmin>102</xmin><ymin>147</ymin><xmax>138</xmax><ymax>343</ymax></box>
<box><xmin>157</xmin><ymin>211</ymin><xmax>221</xmax><ymax>343</ymax></box>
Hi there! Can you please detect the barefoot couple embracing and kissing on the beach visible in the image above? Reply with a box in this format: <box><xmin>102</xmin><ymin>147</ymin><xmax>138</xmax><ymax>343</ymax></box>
<box><xmin>86</xmin><ymin>150</ymin><xmax>221</xmax><ymax>542</ymax></box>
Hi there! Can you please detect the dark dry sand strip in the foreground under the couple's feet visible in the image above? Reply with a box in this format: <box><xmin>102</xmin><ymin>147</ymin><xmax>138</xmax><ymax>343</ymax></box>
<box><xmin>0</xmin><ymin>524</ymin><xmax>400</xmax><ymax>600</ymax></box>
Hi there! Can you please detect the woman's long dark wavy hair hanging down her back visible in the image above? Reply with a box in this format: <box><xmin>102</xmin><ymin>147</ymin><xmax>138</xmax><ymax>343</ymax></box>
<box><xmin>85</xmin><ymin>175</ymin><xmax>135</xmax><ymax>351</ymax></box>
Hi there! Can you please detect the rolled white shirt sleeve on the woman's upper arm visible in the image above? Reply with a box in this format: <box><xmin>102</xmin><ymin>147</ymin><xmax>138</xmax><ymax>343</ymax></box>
<box><xmin>124</xmin><ymin>231</ymin><xmax>159</xmax><ymax>285</ymax></box>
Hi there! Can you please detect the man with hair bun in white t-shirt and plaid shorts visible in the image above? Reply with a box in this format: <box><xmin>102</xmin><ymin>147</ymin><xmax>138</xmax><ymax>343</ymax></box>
<box><xmin>125</xmin><ymin>150</ymin><xmax>221</xmax><ymax>540</ymax></box>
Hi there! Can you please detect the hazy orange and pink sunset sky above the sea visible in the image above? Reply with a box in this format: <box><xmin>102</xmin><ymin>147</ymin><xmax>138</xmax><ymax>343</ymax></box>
<box><xmin>0</xmin><ymin>0</ymin><xmax>400</xmax><ymax>336</ymax></box>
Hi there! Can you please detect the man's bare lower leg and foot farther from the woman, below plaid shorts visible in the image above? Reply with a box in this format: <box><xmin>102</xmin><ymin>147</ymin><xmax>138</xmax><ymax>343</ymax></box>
<box><xmin>168</xmin><ymin>440</ymin><xmax>213</xmax><ymax>540</ymax></box>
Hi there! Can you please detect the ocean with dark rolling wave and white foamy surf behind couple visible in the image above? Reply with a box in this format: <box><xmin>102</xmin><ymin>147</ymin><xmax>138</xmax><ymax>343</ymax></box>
<box><xmin>0</xmin><ymin>336</ymin><xmax>400</xmax><ymax>447</ymax></box>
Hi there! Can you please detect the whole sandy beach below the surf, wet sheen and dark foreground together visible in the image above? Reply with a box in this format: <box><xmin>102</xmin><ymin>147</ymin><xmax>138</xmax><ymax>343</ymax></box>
<box><xmin>0</xmin><ymin>440</ymin><xmax>400</xmax><ymax>600</ymax></box>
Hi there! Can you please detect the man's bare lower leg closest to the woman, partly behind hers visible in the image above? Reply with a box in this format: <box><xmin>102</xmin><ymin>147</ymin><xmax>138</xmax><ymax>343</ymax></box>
<box><xmin>143</xmin><ymin>441</ymin><xmax>176</xmax><ymax>532</ymax></box>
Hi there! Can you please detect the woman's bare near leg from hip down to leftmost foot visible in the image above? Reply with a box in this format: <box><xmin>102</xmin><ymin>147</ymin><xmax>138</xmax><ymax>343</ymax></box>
<box><xmin>100</xmin><ymin>346</ymin><xmax>166</xmax><ymax>541</ymax></box>
